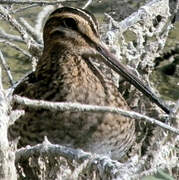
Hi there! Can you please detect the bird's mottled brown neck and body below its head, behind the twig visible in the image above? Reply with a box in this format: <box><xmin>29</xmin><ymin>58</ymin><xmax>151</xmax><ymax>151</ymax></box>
<box><xmin>10</xmin><ymin>51</ymin><xmax>134</xmax><ymax>158</ymax></box>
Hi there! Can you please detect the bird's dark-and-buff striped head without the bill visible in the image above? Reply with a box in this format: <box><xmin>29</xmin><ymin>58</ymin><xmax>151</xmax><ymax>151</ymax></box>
<box><xmin>43</xmin><ymin>7</ymin><xmax>102</xmax><ymax>55</ymax></box>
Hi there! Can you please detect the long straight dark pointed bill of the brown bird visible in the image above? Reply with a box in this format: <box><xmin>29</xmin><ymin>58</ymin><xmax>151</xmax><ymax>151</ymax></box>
<box><xmin>96</xmin><ymin>45</ymin><xmax>170</xmax><ymax>114</ymax></box>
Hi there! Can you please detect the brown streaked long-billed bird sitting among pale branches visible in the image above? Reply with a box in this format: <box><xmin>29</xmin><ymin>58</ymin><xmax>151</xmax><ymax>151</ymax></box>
<box><xmin>9</xmin><ymin>7</ymin><xmax>168</xmax><ymax>159</ymax></box>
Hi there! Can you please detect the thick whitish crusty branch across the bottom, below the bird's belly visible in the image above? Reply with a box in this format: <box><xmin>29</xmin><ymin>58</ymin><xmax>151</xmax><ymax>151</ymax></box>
<box><xmin>15</xmin><ymin>137</ymin><xmax>177</xmax><ymax>180</ymax></box>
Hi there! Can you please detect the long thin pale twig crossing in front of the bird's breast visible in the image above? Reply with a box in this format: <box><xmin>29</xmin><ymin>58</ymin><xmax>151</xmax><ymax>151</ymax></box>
<box><xmin>13</xmin><ymin>95</ymin><xmax>179</xmax><ymax>134</ymax></box>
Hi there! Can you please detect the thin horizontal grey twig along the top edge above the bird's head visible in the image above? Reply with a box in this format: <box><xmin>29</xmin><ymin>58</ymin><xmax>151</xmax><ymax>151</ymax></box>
<box><xmin>0</xmin><ymin>0</ymin><xmax>77</xmax><ymax>6</ymax></box>
